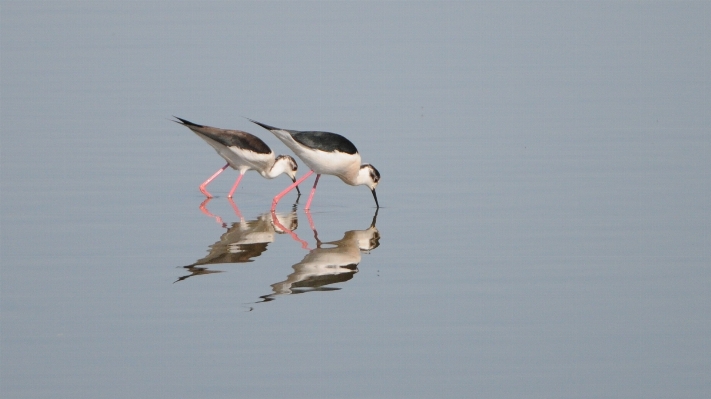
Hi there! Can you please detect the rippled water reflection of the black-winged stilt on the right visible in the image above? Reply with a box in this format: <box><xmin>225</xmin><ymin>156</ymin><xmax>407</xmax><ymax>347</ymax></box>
<box><xmin>260</xmin><ymin>209</ymin><xmax>380</xmax><ymax>302</ymax></box>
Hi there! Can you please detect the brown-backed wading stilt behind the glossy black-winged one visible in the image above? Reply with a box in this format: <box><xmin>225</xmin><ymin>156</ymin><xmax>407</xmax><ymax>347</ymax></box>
<box><xmin>173</xmin><ymin>116</ymin><xmax>301</xmax><ymax>198</ymax></box>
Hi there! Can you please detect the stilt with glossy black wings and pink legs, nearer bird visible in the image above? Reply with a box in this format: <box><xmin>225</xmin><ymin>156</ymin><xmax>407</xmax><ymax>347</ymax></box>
<box><xmin>249</xmin><ymin>119</ymin><xmax>380</xmax><ymax>209</ymax></box>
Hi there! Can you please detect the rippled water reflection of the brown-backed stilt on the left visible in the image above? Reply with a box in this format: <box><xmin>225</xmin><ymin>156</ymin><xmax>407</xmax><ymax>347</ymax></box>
<box><xmin>175</xmin><ymin>198</ymin><xmax>298</xmax><ymax>283</ymax></box>
